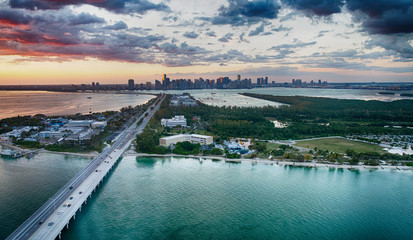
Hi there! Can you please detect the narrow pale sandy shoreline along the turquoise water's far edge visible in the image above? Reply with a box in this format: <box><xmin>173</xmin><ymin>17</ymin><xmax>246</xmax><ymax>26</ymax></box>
<box><xmin>123</xmin><ymin>153</ymin><xmax>413</xmax><ymax>171</ymax></box>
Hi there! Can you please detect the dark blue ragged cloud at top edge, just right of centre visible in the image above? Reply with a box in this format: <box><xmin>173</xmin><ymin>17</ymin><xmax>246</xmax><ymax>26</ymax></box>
<box><xmin>209</xmin><ymin>0</ymin><xmax>280</xmax><ymax>26</ymax></box>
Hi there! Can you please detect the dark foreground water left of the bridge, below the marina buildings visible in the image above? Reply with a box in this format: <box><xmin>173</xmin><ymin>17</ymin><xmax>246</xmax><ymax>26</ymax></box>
<box><xmin>0</xmin><ymin>153</ymin><xmax>90</xmax><ymax>239</ymax></box>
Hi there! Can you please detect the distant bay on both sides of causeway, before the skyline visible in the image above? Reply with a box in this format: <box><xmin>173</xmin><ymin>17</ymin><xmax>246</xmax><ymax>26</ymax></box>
<box><xmin>0</xmin><ymin>88</ymin><xmax>412</xmax><ymax>119</ymax></box>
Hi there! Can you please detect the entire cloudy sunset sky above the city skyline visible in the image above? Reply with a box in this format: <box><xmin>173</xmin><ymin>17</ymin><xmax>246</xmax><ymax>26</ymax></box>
<box><xmin>0</xmin><ymin>0</ymin><xmax>413</xmax><ymax>85</ymax></box>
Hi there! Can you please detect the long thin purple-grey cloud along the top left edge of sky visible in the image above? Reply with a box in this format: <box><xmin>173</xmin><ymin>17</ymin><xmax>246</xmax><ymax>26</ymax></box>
<box><xmin>9</xmin><ymin>0</ymin><xmax>169</xmax><ymax>13</ymax></box>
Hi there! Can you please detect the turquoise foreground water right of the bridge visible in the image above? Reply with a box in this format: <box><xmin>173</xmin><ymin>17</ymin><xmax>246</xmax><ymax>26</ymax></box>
<box><xmin>63</xmin><ymin>157</ymin><xmax>413</xmax><ymax>239</ymax></box>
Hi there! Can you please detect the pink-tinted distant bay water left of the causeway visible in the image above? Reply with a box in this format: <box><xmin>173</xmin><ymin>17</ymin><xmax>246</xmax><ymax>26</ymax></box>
<box><xmin>0</xmin><ymin>91</ymin><xmax>155</xmax><ymax>119</ymax></box>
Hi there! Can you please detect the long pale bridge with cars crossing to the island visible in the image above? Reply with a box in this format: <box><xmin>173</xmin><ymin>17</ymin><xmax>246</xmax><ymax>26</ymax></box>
<box><xmin>7</xmin><ymin>96</ymin><xmax>165</xmax><ymax>240</ymax></box>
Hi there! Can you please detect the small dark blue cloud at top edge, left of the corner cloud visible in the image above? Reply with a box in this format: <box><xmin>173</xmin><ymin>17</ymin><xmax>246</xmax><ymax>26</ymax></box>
<box><xmin>281</xmin><ymin>0</ymin><xmax>344</xmax><ymax>16</ymax></box>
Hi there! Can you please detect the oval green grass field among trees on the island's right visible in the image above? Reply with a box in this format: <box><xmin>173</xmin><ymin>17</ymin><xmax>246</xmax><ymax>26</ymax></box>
<box><xmin>295</xmin><ymin>138</ymin><xmax>385</xmax><ymax>153</ymax></box>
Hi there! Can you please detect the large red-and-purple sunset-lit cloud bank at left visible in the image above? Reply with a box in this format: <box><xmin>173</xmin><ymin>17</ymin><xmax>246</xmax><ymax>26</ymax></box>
<box><xmin>0</xmin><ymin>8</ymin><xmax>172</xmax><ymax>63</ymax></box>
